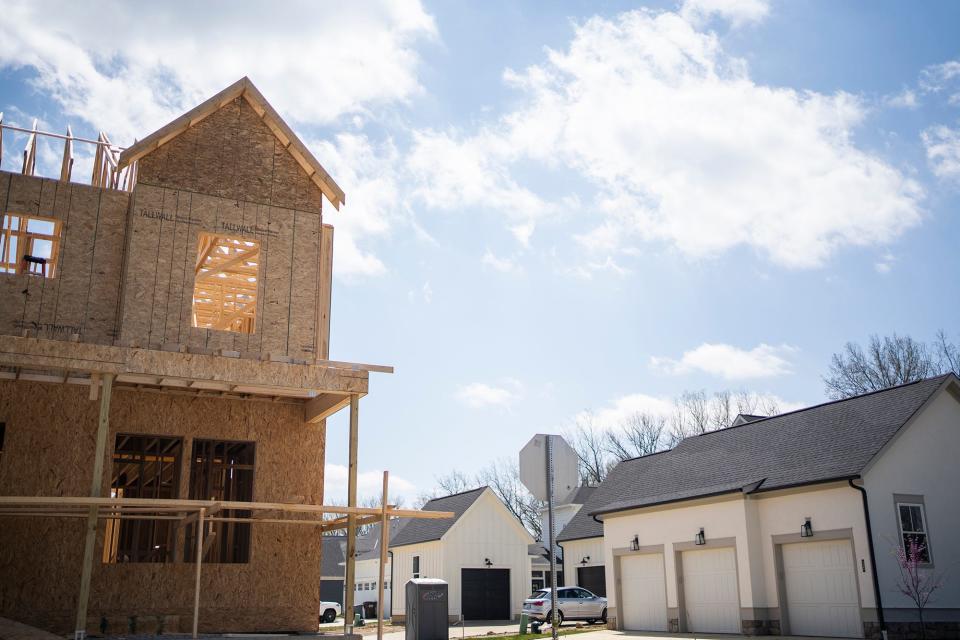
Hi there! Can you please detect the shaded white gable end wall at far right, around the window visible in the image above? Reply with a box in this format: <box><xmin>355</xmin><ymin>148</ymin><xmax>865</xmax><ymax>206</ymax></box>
<box><xmin>860</xmin><ymin>391</ymin><xmax>960</xmax><ymax>620</ymax></box>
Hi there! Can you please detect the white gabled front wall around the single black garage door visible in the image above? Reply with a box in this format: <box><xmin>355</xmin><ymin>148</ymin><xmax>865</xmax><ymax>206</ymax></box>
<box><xmin>442</xmin><ymin>490</ymin><xmax>534</xmax><ymax>617</ymax></box>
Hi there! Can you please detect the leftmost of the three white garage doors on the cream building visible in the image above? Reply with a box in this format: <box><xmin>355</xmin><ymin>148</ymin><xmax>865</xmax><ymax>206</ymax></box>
<box><xmin>620</xmin><ymin>553</ymin><xmax>667</xmax><ymax>631</ymax></box>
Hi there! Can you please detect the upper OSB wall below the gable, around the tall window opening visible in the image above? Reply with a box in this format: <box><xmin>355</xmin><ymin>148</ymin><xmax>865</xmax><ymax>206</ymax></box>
<box><xmin>120</xmin><ymin>184</ymin><xmax>321</xmax><ymax>360</ymax></box>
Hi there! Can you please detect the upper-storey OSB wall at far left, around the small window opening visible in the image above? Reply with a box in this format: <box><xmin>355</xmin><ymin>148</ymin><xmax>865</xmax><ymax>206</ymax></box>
<box><xmin>0</xmin><ymin>172</ymin><xmax>129</xmax><ymax>344</ymax></box>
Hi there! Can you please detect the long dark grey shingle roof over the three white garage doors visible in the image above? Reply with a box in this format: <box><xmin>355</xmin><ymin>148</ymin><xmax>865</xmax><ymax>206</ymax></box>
<box><xmin>588</xmin><ymin>374</ymin><xmax>957</xmax><ymax>520</ymax></box>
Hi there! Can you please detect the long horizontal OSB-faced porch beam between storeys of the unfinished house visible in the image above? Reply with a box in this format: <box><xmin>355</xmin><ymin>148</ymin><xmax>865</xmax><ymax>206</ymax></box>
<box><xmin>0</xmin><ymin>335</ymin><xmax>369</xmax><ymax>394</ymax></box>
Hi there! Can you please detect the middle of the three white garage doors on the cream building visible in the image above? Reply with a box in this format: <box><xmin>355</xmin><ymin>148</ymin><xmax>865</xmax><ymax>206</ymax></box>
<box><xmin>682</xmin><ymin>548</ymin><xmax>740</xmax><ymax>633</ymax></box>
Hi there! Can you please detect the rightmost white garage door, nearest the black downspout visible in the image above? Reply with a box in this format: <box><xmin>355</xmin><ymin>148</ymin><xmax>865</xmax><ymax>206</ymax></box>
<box><xmin>783</xmin><ymin>540</ymin><xmax>863</xmax><ymax>638</ymax></box>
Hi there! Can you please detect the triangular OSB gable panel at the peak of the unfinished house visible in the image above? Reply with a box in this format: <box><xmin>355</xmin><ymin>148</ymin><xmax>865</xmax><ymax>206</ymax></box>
<box><xmin>137</xmin><ymin>97</ymin><xmax>322</xmax><ymax>213</ymax></box>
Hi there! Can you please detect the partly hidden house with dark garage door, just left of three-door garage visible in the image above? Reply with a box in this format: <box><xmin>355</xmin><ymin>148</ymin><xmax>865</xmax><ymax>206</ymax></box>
<box><xmin>557</xmin><ymin>492</ymin><xmax>607</xmax><ymax>596</ymax></box>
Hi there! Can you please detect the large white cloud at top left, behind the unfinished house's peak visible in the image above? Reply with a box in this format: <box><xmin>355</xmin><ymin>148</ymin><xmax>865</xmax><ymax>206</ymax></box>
<box><xmin>0</xmin><ymin>0</ymin><xmax>436</xmax><ymax>144</ymax></box>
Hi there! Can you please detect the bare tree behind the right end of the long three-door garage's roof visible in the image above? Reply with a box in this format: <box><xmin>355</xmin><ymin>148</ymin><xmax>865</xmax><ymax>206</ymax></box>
<box><xmin>824</xmin><ymin>331</ymin><xmax>960</xmax><ymax>400</ymax></box>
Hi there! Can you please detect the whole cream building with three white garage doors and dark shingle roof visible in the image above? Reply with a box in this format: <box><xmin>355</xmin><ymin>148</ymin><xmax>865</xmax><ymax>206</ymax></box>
<box><xmin>592</xmin><ymin>374</ymin><xmax>960</xmax><ymax>638</ymax></box>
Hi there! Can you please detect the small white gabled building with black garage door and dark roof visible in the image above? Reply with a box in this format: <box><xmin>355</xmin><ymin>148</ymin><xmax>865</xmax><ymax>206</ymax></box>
<box><xmin>390</xmin><ymin>487</ymin><xmax>534</xmax><ymax>622</ymax></box>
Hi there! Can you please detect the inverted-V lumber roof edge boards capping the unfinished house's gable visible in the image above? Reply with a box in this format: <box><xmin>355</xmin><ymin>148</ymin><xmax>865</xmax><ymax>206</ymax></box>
<box><xmin>120</xmin><ymin>76</ymin><xmax>346</xmax><ymax>209</ymax></box>
